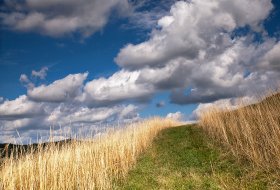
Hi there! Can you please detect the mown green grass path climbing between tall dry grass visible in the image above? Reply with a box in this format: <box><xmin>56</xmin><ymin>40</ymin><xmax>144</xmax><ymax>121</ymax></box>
<box><xmin>115</xmin><ymin>126</ymin><xmax>279</xmax><ymax>190</ymax></box>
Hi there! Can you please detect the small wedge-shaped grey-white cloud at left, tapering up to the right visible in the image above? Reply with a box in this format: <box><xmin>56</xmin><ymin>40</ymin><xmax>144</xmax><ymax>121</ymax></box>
<box><xmin>27</xmin><ymin>73</ymin><xmax>88</xmax><ymax>102</ymax></box>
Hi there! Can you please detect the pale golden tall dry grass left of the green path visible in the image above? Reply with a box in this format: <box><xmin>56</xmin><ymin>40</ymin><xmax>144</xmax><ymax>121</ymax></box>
<box><xmin>0</xmin><ymin>118</ymin><xmax>178</xmax><ymax>190</ymax></box>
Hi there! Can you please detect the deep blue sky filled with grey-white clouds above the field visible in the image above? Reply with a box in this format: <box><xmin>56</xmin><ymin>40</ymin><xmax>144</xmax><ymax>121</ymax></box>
<box><xmin>0</xmin><ymin>0</ymin><xmax>280</xmax><ymax>143</ymax></box>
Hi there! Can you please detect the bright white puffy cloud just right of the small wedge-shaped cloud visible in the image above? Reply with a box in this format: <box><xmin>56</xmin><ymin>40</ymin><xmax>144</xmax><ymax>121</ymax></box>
<box><xmin>78</xmin><ymin>70</ymin><xmax>154</xmax><ymax>106</ymax></box>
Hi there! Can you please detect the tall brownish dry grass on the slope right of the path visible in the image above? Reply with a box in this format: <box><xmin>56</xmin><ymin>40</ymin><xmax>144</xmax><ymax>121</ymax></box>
<box><xmin>200</xmin><ymin>93</ymin><xmax>280</xmax><ymax>171</ymax></box>
